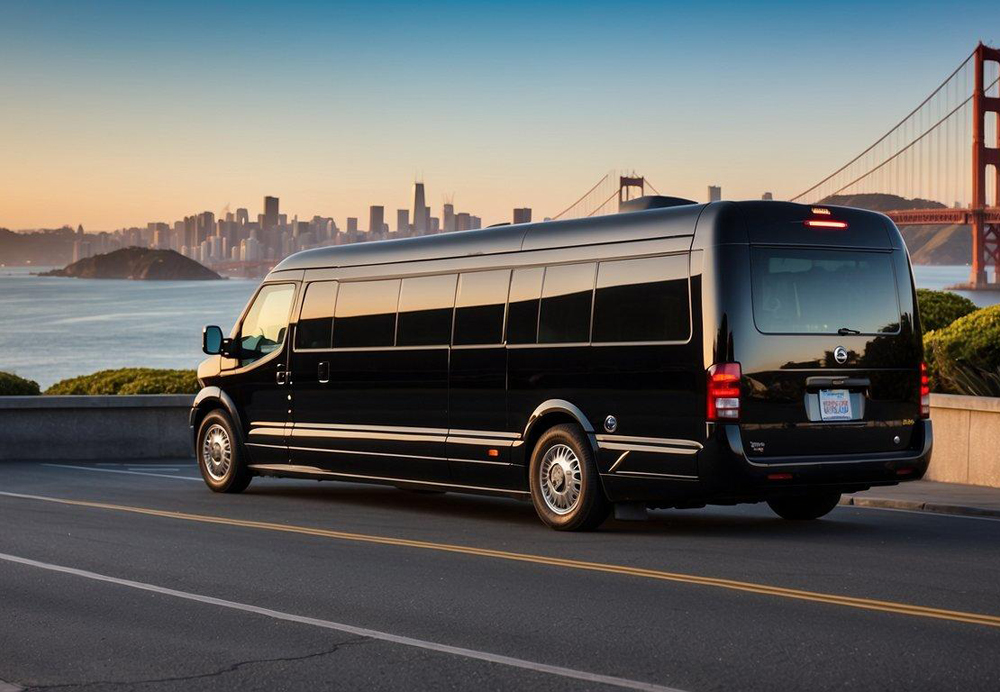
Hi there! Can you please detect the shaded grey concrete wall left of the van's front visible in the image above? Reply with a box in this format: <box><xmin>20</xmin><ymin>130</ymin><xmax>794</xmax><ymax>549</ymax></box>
<box><xmin>0</xmin><ymin>394</ymin><xmax>194</xmax><ymax>462</ymax></box>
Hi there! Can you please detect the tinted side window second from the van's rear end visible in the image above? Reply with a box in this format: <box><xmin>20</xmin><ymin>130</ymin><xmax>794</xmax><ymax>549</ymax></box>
<box><xmin>538</xmin><ymin>264</ymin><xmax>595</xmax><ymax>344</ymax></box>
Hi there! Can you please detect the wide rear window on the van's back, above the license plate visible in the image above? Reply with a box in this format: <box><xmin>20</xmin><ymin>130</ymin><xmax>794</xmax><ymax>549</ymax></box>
<box><xmin>751</xmin><ymin>247</ymin><xmax>899</xmax><ymax>334</ymax></box>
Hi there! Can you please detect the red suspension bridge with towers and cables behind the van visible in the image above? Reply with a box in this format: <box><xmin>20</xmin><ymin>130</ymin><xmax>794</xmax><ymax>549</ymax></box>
<box><xmin>553</xmin><ymin>43</ymin><xmax>1000</xmax><ymax>288</ymax></box>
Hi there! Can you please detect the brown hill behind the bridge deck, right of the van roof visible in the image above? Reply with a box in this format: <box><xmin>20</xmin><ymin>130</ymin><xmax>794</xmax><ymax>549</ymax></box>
<box><xmin>820</xmin><ymin>193</ymin><xmax>972</xmax><ymax>265</ymax></box>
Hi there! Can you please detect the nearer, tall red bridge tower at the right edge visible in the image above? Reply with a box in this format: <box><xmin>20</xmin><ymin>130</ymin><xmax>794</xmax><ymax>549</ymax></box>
<box><xmin>969</xmin><ymin>43</ymin><xmax>1000</xmax><ymax>288</ymax></box>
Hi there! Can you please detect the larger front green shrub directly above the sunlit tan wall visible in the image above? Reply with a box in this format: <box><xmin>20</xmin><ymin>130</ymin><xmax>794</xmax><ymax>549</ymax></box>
<box><xmin>924</xmin><ymin>305</ymin><xmax>1000</xmax><ymax>396</ymax></box>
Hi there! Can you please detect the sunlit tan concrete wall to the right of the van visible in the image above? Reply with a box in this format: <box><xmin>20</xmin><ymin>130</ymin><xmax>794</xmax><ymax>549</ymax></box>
<box><xmin>924</xmin><ymin>394</ymin><xmax>1000</xmax><ymax>488</ymax></box>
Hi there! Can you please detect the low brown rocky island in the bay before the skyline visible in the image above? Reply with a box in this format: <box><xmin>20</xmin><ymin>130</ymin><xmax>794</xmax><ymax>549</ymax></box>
<box><xmin>41</xmin><ymin>247</ymin><xmax>223</xmax><ymax>281</ymax></box>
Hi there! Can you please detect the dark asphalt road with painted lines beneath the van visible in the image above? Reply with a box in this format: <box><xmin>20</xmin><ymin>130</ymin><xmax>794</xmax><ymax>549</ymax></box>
<box><xmin>0</xmin><ymin>462</ymin><xmax>1000</xmax><ymax>692</ymax></box>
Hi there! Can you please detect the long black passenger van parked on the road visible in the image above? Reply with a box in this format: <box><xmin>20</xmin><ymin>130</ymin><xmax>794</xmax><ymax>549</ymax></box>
<box><xmin>190</xmin><ymin>199</ymin><xmax>932</xmax><ymax>529</ymax></box>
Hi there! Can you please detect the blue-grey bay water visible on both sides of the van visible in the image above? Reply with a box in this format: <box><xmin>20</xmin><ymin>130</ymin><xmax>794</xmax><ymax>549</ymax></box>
<box><xmin>0</xmin><ymin>266</ymin><xmax>1000</xmax><ymax>388</ymax></box>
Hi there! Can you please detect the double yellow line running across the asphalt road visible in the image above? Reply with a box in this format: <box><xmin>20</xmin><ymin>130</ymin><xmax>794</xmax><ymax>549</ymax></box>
<box><xmin>0</xmin><ymin>491</ymin><xmax>1000</xmax><ymax>627</ymax></box>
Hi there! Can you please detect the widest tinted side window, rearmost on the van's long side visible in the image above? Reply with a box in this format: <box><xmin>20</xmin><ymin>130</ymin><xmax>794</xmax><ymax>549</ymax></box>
<box><xmin>594</xmin><ymin>255</ymin><xmax>691</xmax><ymax>342</ymax></box>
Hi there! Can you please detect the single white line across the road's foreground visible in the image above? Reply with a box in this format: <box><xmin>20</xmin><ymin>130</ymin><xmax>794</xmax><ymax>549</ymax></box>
<box><xmin>0</xmin><ymin>553</ymin><xmax>682</xmax><ymax>692</ymax></box>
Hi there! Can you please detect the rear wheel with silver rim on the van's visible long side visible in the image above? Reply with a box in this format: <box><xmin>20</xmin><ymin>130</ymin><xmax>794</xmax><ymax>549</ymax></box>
<box><xmin>528</xmin><ymin>425</ymin><xmax>611</xmax><ymax>531</ymax></box>
